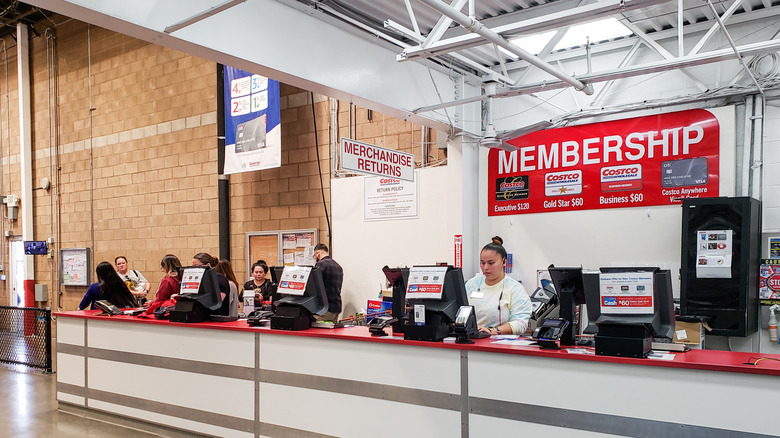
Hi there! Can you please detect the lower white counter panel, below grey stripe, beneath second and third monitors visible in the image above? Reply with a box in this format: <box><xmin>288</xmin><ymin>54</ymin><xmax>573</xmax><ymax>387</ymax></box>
<box><xmin>260</xmin><ymin>383</ymin><xmax>460</xmax><ymax>438</ymax></box>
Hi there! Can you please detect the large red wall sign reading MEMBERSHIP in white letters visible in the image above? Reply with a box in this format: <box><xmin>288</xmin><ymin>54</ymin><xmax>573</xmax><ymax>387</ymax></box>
<box><xmin>488</xmin><ymin>110</ymin><xmax>720</xmax><ymax>216</ymax></box>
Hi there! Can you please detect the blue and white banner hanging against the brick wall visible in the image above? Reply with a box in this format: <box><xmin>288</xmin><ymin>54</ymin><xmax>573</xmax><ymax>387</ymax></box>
<box><xmin>223</xmin><ymin>66</ymin><xmax>282</xmax><ymax>174</ymax></box>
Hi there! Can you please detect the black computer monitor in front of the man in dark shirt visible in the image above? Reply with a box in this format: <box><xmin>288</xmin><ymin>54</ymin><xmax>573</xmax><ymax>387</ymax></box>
<box><xmin>271</xmin><ymin>266</ymin><xmax>328</xmax><ymax>330</ymax></box>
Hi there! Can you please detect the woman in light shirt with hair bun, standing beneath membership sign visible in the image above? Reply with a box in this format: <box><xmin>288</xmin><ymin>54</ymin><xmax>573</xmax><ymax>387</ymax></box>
<box><xmin>466</xmin><ymin>243</ymin><xmax>531</xmax><ymax>335</ymax></box>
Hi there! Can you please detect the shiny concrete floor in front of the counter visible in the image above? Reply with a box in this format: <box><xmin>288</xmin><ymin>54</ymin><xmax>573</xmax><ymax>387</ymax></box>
<box><xmin>0</xmin><ymin>364</ymin><xmax>155</xmax><ymax>438</ymax></box>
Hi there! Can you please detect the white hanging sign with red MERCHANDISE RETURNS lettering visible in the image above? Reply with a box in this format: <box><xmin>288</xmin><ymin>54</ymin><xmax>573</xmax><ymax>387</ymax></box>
<box><xmin>341</xmin><ymin>138</ymin><xmax>414</xmax><ymax>181</ymax></box>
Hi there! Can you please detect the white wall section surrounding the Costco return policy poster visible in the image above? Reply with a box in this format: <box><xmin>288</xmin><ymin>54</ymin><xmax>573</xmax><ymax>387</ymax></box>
<box><xmin>331</xmin><ymin>164</ymin><xmax>461</xmax><ymax>318</ymax></box>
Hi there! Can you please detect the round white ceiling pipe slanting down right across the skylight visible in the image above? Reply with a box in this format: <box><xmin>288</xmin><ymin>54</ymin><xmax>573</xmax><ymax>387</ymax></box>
<box><xmin>421</xmin><ymin>0</ymin><xmax>593</xmax><ymax>95</ymax></box>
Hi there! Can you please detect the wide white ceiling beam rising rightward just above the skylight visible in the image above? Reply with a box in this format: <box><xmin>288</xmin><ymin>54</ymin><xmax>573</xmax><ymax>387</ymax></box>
<box><xmin>397</xmin><ymin>0</ymin><xmax>669</xmax><ymax>61</ymax></box>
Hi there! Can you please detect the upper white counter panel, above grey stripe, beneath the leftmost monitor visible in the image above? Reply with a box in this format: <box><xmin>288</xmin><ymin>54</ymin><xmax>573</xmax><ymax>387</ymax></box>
<box><xmin>86</xmin><ymin>318</ymin><xmax>255</xmax><ymax>367</ymax></box>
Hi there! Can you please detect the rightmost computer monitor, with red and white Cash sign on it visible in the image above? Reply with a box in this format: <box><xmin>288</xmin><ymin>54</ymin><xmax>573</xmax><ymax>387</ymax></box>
<box><xmin>582</xmin><ymin>266</ymin><xmax>675</xmax><ymax>339</ymax></box>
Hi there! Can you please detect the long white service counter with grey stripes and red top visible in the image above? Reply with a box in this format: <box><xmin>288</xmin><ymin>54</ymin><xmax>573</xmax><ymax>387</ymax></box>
<box><xmin>56</xmin><ymin>311</ymin><xmax>780</xmax><ymax>438</ymax></box>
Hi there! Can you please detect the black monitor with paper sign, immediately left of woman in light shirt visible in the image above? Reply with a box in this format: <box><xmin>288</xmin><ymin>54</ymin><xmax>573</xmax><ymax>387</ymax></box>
<box><xmin>404</xmin><ymin>266</ymin><xmax>469</xmax><ymax>341</ymax></box>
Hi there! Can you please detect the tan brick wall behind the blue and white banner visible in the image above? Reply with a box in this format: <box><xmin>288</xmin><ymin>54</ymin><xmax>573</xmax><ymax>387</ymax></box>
<box><xmin>0</xmin><ymin>21</ymin><xmax>444</xmax><ymax>310</ymax></box>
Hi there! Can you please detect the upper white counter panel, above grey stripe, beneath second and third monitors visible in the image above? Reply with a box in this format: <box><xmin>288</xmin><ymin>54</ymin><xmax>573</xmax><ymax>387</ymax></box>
<box><xmin>260</xmin><ymin>334</ymin><xmax>460</xmax><ymax>394</ymax></box>
